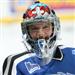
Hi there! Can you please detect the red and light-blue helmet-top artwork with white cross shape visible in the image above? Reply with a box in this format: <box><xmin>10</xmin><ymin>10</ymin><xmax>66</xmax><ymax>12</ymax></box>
<box><xmin>23</xmin><ymin>4</ymin><xmax>50</xmax><ymax>19</ymax></box>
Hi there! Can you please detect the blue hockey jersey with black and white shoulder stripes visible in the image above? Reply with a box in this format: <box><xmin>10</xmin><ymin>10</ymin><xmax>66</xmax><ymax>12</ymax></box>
<box><xmin>3</xmin><ymin>47</ymin><xmax>75</xmax><ymax>75</ymax></box>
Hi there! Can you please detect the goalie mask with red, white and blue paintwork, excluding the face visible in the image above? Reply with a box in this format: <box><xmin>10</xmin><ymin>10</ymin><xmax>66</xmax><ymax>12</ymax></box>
<box><xmin>21</xmin><ymin>2</ymin><xmax>60</xmax><ymax>58</ymax></box>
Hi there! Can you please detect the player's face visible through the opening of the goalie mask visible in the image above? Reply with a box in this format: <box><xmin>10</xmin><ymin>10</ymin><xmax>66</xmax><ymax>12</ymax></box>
<box><xmin>28</xmin><ymin>22</ymin><xmax>53</xmax><ymax>40</ymax></box>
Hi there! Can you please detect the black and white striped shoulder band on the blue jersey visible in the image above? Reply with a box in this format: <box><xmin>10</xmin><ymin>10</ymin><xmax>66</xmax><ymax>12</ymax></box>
<box><xmin>2</xmin><ymin>51</ymin><xmax>34</xmax><ymax>75</ymax></box>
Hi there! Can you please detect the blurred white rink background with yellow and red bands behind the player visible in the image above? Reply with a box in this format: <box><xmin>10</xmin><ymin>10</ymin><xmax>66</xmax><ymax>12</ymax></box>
<box><xmin>0</xmin><ymin>0</ymin><xmax>75</xmax><ymax>71</ymax></box>
